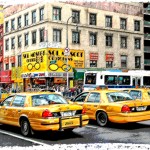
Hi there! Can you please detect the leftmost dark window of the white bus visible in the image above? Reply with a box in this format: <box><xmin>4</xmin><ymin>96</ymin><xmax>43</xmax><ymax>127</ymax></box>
<box><xmin>85</xmin><ymin>73</ymin><xmax>96</xmax><ymax>84</ymax></box>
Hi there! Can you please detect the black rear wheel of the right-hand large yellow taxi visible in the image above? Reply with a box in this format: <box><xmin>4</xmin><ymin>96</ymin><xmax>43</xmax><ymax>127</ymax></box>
<box><xmin>96</xmin><ymin>111</ymin><xmax>109</xmax><ymax>127</ymax></box>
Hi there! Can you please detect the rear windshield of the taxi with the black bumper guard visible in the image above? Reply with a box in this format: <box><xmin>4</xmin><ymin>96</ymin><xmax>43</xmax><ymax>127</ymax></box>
<box><xmin>32</xmin><ymin>94</ymin><xmax>68</xmax><ymax>106</ymax></box>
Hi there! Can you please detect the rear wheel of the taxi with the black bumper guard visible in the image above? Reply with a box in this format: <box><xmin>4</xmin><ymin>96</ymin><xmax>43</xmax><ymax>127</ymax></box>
<box><xmin>21</xmin><ymin>119</ymin><xmax>31</xmax><ymax>136</ymax></box>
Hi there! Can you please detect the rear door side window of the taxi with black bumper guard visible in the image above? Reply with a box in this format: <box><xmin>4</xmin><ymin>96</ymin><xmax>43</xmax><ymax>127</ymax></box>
<box><xmin>12</xmin><ymin>95</ymin><xmax>26</xmax><ymax>107</ymax></box>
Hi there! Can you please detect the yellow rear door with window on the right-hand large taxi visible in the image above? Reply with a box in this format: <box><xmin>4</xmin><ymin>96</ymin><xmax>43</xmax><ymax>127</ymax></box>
<box><xmin>83</xmin><ymin>92</ymin><xmax>100</xmax><ymax>119</ymax></box>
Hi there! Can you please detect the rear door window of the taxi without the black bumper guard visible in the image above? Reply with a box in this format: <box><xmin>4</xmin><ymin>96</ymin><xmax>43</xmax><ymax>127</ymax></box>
<box><xmin>87</xmin><ymin>93</ymin><xmax>100</xmax><ymax>103</ymax></box>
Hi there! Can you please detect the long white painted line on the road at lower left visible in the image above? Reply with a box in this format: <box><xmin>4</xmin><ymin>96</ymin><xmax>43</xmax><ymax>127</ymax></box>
<box><xmin>0</xmin><ymin>130</ymin><xmax>49</xmax><ymax>146</ymax></box>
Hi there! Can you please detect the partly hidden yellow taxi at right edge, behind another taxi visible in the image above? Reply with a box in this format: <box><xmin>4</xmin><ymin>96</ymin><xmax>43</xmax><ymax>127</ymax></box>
<box><xmin>124</xmin><ymin>88</ymin><xmax>150</xmax><ymax>100</ymax></box>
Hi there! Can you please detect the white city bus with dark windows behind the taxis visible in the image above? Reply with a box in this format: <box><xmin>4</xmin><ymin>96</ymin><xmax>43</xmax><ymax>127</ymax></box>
<box><xmin>83</xmin><ymin>70</ymin><xmax>150</xmax><ymax>90</ymax></box>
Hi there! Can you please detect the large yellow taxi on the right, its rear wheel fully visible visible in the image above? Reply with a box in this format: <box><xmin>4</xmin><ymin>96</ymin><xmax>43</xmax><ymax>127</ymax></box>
<box><xmin>71</xmin><ymin>89</ymin><xmax>150</xmax><ymax>126</ymax></box>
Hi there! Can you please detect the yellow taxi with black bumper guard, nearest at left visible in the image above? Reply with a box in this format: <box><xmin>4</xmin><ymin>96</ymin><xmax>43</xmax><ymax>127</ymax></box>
<box><xmin>0</xmin><ymin>92</ymin><xmax>89</xmax><ymax>136</ymax></box>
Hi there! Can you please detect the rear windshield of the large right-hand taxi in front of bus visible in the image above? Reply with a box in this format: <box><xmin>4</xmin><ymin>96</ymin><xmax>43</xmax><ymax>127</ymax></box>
<box><xmin>106</xmin><ymin>92</ymin><xmax>134</xmax><ymax>102</ymax></box>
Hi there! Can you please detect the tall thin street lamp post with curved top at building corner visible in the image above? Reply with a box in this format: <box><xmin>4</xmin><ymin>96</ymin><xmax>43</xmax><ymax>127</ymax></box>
<box><xmin>66</xmin><ymin>16</ymin><xmax>74</xmax><ymax>90</ymax></box>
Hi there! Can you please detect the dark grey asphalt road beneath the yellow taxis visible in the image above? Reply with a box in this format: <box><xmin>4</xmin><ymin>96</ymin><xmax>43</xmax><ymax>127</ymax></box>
<box><xmin>0</xmin><ymin>121</ymin><xmax>150</xmax><ymax>146</ymax></box>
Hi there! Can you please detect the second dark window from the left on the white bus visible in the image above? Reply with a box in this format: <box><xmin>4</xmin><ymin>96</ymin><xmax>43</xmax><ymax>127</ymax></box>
<box><xmin>104</xmin><ymin>75</ymin><xmax>117</xmax><ymax>85</ymax></box>
